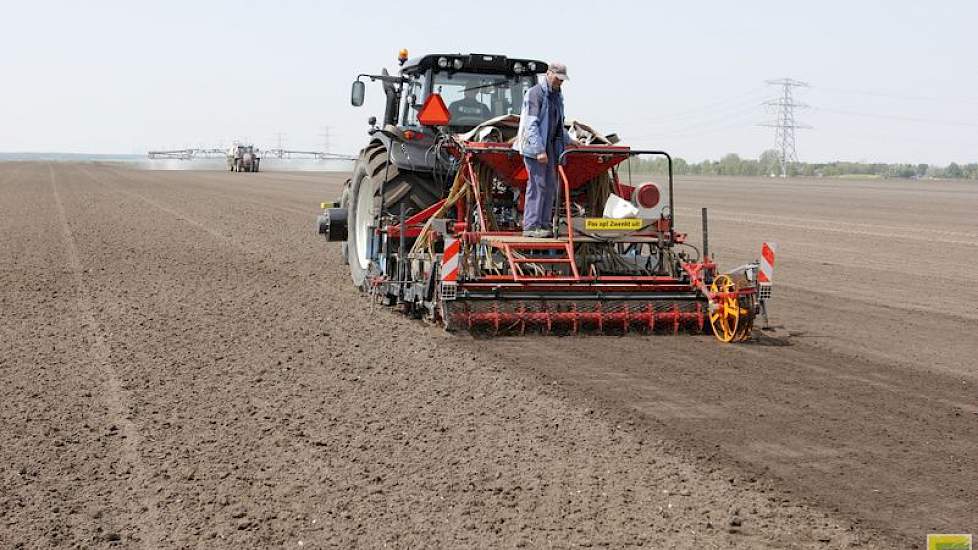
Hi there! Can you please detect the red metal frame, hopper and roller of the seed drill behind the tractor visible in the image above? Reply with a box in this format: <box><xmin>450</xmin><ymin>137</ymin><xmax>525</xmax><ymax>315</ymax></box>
<box><xmin>378</xmin><ymin>142</ymin><xmax>756</xmax><ymax>332</ymax></box>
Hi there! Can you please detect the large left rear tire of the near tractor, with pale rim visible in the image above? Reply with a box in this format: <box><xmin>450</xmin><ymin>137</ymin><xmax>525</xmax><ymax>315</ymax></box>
<box><xmin>344</xmin><ymin>143</ymin><xmax>442</xmax><ymax>289</ymax></box>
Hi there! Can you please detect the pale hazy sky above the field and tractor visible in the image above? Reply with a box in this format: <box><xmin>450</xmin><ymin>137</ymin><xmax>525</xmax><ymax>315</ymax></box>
<box><xmin>0</xmin><ymin>0</ymin><xmax>978</xmax><ymax>164</ymax></box>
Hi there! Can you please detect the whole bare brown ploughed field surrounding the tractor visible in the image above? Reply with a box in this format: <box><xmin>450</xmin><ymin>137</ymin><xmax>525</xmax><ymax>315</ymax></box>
<box><xmin>0</xmin><ymin>163</ymin><xmax>978</xmax><ymax>549</ymax></box>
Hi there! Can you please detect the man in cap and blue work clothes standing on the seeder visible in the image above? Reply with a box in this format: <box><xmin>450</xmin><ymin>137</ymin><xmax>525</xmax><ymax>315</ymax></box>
<box><xmin>513</xmin><ymin>62</ymin><xmax>576</xmax><ymax>237</ymax></box>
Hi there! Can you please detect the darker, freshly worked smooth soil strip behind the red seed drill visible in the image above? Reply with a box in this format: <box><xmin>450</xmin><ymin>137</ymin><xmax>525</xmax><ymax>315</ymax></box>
<box><xmin>480</xmin><ymin>336</ymin><xmax>978</xmax><ymax>544</ymax></box>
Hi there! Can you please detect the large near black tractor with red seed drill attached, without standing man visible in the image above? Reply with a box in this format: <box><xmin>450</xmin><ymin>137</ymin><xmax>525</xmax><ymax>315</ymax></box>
<box><xmin>317</xmin><ymin>50</ymin><xmax>776</xmax><ymax>342</ymax></box>
